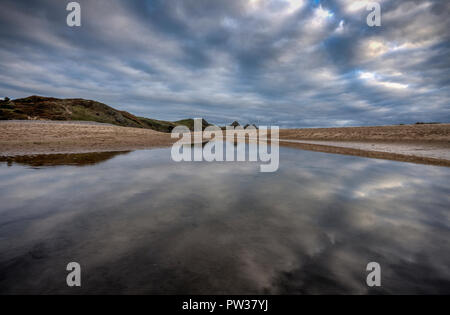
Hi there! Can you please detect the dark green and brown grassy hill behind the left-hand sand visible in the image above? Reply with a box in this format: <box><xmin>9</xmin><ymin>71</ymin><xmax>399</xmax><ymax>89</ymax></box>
<box><xmin>0</xmin><ymin>96</ymin><xmax>210</xmax><ymax>132</ymax></box>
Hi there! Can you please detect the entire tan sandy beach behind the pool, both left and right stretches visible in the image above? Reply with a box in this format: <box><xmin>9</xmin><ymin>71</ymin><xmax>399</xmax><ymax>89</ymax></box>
<box><xmin>0</xmin><ymin>121</ymin><xmax>450</xmax><ymax>166</ymax></box>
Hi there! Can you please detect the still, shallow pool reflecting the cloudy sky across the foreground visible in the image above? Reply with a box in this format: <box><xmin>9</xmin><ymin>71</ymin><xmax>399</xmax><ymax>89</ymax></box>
<box><xmin>0</xmin><ymin>148</ymin><xmax>450</xmax><ymax>294</ymax></box>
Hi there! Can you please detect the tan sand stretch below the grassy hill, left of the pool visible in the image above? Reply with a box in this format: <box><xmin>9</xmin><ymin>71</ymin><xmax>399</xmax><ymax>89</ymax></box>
<box><xmin>0</xmin><ymin>121</ymin><xmax>173</xmax><ymax>156</ymax></box>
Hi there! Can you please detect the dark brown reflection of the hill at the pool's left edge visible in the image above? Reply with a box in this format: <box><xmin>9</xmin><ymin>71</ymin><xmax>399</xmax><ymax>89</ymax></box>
<box><xmin>0</xmin><ymin>151</ymin><xmax>130</xmax><ymax>167</ymax></box>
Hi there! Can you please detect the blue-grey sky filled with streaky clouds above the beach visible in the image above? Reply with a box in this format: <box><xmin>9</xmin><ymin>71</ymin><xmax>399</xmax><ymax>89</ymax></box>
<box><xmin>0</xmin><ymin>0</ymin><xmax>450</xmax><ymax>127</ymax></box>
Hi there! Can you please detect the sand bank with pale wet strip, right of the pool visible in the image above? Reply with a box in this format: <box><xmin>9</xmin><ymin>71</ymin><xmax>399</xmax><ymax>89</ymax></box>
<box><xmin>280</xmin><ymin>124</ymin><xmax>450</xmax><ymax>167</ymax></box>
